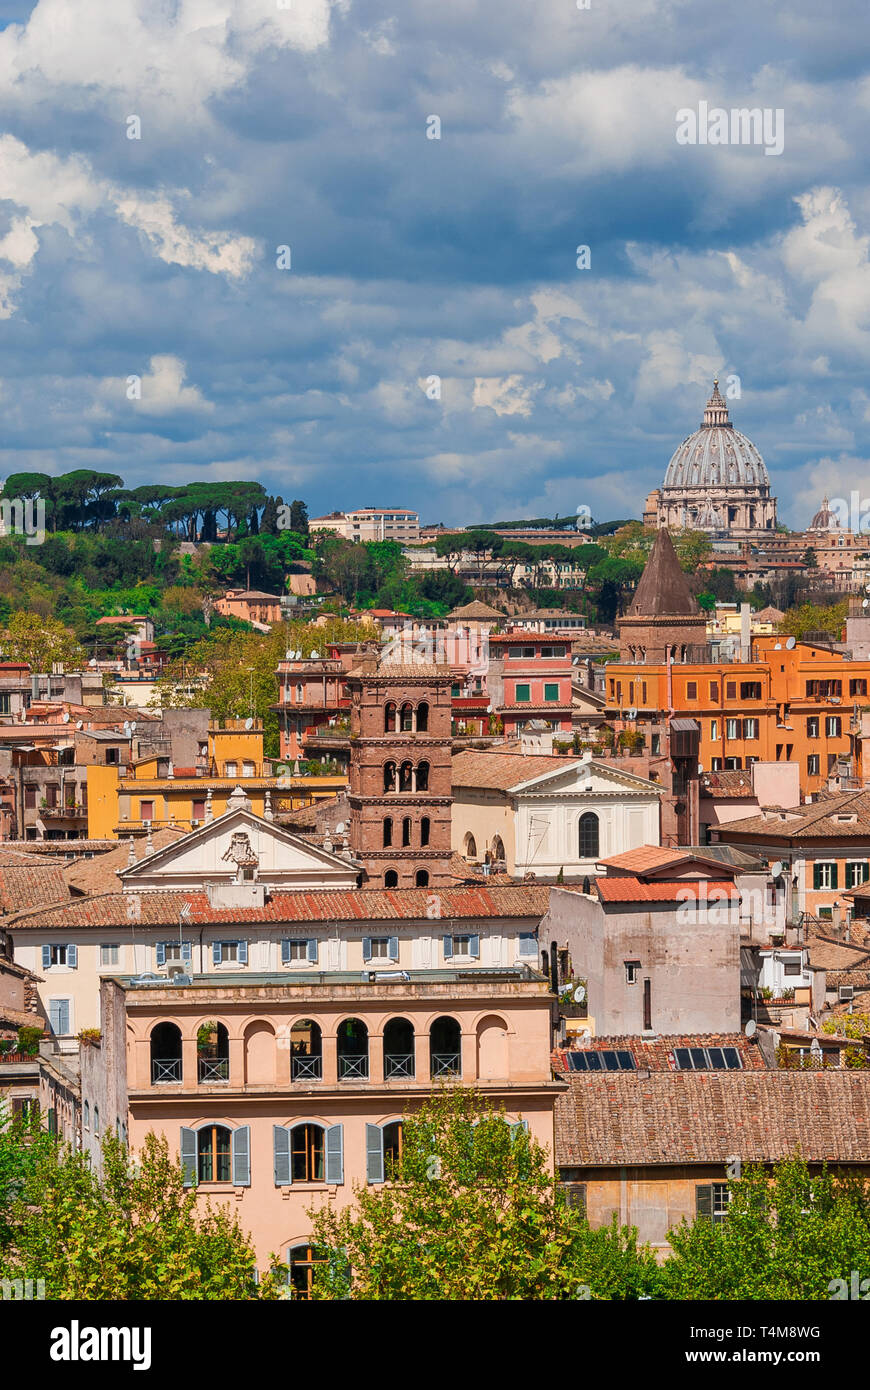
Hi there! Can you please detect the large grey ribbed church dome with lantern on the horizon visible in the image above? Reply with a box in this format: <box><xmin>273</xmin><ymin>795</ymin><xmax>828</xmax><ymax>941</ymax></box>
<box><xmin>643</xmin><ymin>381</ymin><xmax>777</xmax><ymax>539</ymax></box>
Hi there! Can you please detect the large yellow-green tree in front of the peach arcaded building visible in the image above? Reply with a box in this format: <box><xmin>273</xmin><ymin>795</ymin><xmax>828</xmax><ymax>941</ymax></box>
<box><xmin>296</xmin><ymin>1087</ymin><xmax>657</xmax><ymax>1300</ymax></box>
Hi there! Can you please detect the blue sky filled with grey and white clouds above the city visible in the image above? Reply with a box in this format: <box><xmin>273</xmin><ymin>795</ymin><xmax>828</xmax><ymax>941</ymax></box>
<box><xmin>0</xmin><ymin>0</ymin><xmax>870</xmax><ymax>527</ymax></box>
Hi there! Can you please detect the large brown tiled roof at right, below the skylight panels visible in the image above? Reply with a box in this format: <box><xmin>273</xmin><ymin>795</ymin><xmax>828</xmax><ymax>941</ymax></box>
<box><xmin>556</xmin><ymin>1069</ymin><xmax>870</xmax><ymax>1168</ymax></box>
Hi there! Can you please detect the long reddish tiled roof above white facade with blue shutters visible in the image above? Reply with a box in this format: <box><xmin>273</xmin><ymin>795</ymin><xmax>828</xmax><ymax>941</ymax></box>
<box><xmin>4</xmin><ymin>884</ymin><xmax>550</xmax><ymax>931</ymax></box>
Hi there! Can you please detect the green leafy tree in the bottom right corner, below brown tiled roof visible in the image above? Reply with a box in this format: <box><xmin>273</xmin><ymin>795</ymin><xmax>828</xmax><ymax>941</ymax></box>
<box><xmin>662</xmin><ymin>1158</ymin><xmax>870</xmax><ymax>1300</ymax></box>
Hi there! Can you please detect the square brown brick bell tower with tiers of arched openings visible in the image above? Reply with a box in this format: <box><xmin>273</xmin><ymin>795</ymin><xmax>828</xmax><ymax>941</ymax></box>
<box><xmin>347</xmin><ymin>657</ymin><xmax>453</xmax><ymax>888</ymax></box>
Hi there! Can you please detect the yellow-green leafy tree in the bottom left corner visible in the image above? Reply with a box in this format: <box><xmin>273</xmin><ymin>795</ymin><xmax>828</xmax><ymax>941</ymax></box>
<box><xmin>0</xmin><ymin>1134</ymin><xmax>260</xmax><ymax>1301</ymax></box>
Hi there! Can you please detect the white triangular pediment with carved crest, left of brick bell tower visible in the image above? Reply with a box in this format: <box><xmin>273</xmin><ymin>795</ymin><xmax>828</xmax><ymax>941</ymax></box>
<box><xmin>120</xmin><ymin>809</ymin><xmax>360</xmax><ymax>891</ymax></box>
